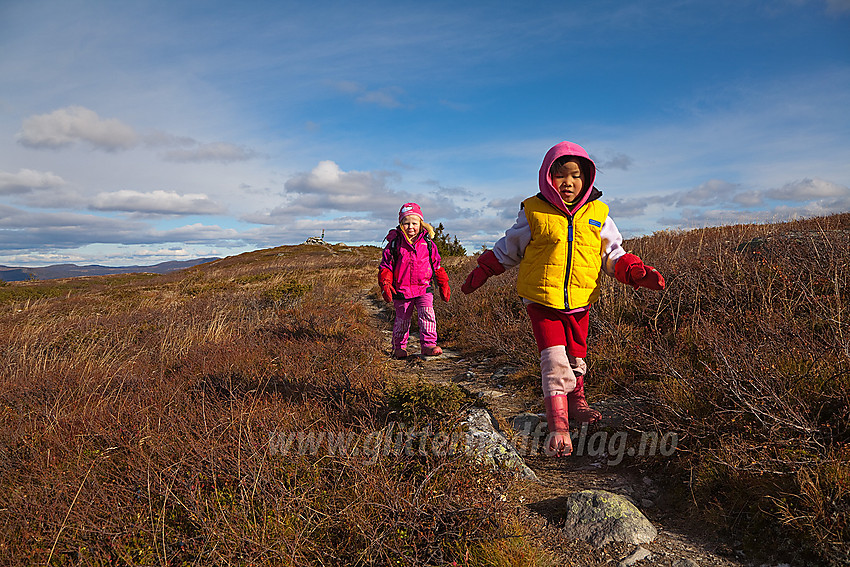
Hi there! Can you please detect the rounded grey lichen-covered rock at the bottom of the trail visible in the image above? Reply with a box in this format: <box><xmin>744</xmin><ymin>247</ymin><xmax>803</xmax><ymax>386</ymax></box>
<box><xmin>564</xmin><ymin>490</ymin><xmax>658</xmax><ymax>547</ymax></box>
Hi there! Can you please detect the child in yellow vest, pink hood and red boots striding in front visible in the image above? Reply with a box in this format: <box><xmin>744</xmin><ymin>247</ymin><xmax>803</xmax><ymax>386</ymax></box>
<box><xmin>461</xmin><ymin>142</ymin><xmax>665</xmax><ymax>456</ymax></box>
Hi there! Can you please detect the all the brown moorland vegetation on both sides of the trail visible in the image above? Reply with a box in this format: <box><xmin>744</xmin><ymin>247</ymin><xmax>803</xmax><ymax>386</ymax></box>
<box><xmin>0</xmin><ymin>214</ymin><xmax>850</xmax><ymax>565</ymax></box>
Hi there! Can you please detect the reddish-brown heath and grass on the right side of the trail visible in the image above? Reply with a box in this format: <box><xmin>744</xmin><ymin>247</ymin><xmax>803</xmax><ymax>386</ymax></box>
<box><xmin>438</xmin><ymin>214</ymin><xmax>850</xmax><ymax>565</ymax></box>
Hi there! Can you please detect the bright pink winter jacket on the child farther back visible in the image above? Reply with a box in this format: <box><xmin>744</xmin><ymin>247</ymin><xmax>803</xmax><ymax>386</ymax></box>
<box><xmin>378</xmin><ymin>228</ymin><xmax>440</xmax><ymax>299</ymax></box>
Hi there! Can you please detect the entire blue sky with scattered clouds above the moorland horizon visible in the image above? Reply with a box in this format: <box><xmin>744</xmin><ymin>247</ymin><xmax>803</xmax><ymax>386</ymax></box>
<box><xmin>0</xmin><ymin>0</ymin><xmax>850</xmax><ymax>266</ymax></box>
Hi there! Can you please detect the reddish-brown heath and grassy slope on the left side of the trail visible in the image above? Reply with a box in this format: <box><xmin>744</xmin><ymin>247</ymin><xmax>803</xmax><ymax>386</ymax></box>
<box><xmin>0</xmin><ymin>245</ymin><xmax>535</xmax><ymax>565</ymax></box>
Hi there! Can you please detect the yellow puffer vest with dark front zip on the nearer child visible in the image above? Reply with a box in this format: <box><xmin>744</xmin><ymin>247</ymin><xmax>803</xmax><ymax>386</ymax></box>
<box><xmin>517</xmin><ymin>196</ymin><xmax>608</xmax><ymax>309</ymax></box>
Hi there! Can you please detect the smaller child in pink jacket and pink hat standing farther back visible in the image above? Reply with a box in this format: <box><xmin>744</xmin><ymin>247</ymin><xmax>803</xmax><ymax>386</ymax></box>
<box><xmin>378</xmin><ymin>203</ymin><xmax>451</xmax><ymax>358</ymax></box>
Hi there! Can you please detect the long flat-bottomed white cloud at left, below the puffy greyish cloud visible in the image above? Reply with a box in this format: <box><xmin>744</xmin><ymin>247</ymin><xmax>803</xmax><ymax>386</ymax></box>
<box><xmin>91</xmin><ymin>189</ymin><xmax>224</xmax><ymax>215</ymax></box>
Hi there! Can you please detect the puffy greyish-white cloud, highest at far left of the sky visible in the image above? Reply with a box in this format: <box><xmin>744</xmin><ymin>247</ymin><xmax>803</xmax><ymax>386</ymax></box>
<box><xmin>17</xmin><ymin>106</ymin><xmax>138</xmax><ymax>151</ymax></box>
